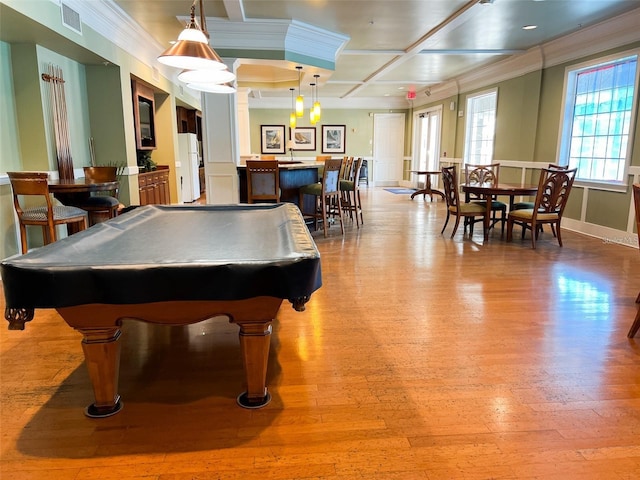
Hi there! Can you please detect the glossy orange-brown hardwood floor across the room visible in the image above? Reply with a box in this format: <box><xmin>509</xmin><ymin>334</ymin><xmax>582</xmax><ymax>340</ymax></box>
<box><xmin>0</xmin><ymin>188</ymin><xmax>640</xmax><ymax>480</ymax></box>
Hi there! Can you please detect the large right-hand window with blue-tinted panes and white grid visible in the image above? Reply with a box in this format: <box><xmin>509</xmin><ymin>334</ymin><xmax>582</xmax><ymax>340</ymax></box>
<box><xmin>559</xmin><ymin>54</ymin><xmax>638</xmax><ymax>183</ymax></box>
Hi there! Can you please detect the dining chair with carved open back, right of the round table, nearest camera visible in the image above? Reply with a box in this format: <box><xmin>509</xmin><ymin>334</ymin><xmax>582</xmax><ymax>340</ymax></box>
<box><xmin>507</xmin><ymin>168</ymin><xmax>577</xmax><ymax>248</ymax></box>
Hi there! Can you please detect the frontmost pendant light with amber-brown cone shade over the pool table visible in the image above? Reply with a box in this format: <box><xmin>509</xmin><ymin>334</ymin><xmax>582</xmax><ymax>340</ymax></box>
<box><xmin>158</xmin><ymin>0</ymin><xmax>226</xmax><ymax>70</ymax></box>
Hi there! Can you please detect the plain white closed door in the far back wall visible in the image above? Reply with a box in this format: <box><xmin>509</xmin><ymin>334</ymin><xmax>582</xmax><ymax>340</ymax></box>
<box><xmin>373</xmin><ymin>113</ymin><xmax>404</xmax><ymax>186</ymax></box>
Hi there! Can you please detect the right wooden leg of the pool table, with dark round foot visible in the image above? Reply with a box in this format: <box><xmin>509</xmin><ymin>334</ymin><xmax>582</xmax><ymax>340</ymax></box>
<box><xmin>236</xmin><ymin>321</ymin><xmax>271</xmax><ymax>408</ymax></box>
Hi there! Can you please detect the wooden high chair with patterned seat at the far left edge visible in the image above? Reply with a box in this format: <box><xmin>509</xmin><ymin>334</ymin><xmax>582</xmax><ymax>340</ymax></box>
<box><xmin>7</xmin><ymin>172</ymin><xmax>88</xmax><ymax>253</ymax></box>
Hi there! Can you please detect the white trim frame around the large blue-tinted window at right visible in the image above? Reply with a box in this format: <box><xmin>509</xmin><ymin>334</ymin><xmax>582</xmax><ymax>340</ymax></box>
<box><xmin>556</xmin><ymin>48</ymin><xmax>640</xmax><ymax>192</ymax></box>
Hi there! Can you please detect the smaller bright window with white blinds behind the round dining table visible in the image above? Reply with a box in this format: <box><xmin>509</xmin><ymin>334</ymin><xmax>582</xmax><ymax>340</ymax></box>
<box><xmin>464</xmin><ymin>90</ymin><xmax>498</xmax><ymax>165</ymax></box>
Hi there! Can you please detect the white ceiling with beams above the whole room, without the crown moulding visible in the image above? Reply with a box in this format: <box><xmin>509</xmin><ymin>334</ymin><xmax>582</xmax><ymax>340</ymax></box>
<box><xmin>109</xmin><ymin>0</ymin><xmax>640</xmax><ymax>106</ymax></box>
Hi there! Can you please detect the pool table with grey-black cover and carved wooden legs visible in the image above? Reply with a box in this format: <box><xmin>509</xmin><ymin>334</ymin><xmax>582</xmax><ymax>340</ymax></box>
<box><xmin>0</xmin><ymin>204</ymin><xmax>322</xmax><ymax>417</ymax></box>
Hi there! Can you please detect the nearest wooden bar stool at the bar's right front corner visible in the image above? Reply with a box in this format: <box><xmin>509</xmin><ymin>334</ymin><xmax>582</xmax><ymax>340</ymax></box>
<box><xmin>299</xmin><ymin>158</ymin><xmax>344</xmax><ymax>237</ymax></box>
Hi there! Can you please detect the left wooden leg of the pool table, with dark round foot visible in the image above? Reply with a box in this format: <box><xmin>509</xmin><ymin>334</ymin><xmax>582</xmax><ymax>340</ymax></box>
<box><xmin>79</xmin><ymin>327</ymin><xmax>122</xmax><ymax>418</ymax></box>
